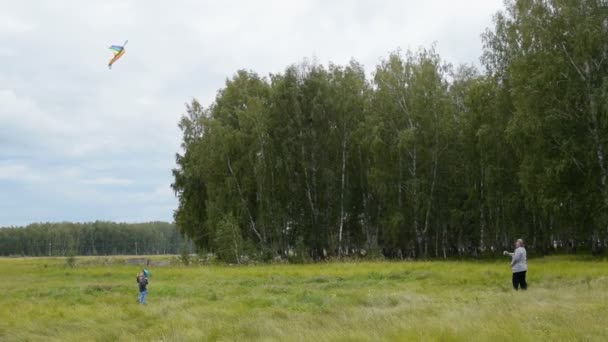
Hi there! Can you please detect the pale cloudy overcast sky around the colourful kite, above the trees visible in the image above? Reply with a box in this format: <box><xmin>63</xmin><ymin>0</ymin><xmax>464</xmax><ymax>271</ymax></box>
<box><xmin>0</xmin><ymin>0</ymin><xmax>502</xmax><ymax>226</ymax></box>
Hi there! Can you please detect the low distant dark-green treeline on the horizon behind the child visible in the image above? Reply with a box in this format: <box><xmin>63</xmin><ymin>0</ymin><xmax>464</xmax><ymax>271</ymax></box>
<box><xmin>0</xmin><ymin>221</ymin><xmax>192</xmax><ymax>256</ymax></box>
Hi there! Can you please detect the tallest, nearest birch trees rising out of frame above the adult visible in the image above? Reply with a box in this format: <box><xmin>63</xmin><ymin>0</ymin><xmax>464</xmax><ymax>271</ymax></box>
<box><xmin>484</xmin><ymin>0</ymin><xmax>608</xmax><ymax>251</ymax></box>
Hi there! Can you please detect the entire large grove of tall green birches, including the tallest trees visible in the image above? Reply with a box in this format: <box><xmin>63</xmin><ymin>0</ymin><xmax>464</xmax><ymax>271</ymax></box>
<box><xmin>172</xmin><ymin>0</ymin><xmax>608</xmax><ymax>262</ymax></box>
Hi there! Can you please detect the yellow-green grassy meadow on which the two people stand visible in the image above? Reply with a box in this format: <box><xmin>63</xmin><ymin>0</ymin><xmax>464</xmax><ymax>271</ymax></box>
<box><xmin>0</xmin><ymin>257</ymin><xmax>608</xmax><ymax>341</ymax></box>
